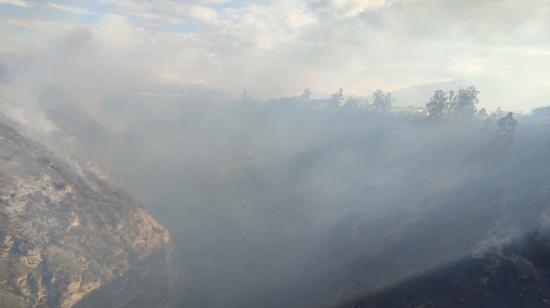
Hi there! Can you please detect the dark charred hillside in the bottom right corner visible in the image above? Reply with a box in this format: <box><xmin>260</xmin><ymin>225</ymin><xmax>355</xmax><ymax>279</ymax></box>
<box><xmin>341</xmin><ymin>233</ymin><xmax>550</xmax><ymax>308</ymax></box>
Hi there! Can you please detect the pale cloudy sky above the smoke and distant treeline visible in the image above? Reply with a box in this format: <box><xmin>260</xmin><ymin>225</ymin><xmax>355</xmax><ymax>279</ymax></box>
<box><xmin>0</xmin><ymin>0</ymin><xmax>550</xmax><ymax>110</ymax></box>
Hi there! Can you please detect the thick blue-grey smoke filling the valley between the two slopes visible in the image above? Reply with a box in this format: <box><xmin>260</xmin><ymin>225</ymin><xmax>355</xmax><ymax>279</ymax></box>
<box><xmin>0</xmin><ymin>7</ymin><xmax>550</xmax><ymax>307</ymax></box>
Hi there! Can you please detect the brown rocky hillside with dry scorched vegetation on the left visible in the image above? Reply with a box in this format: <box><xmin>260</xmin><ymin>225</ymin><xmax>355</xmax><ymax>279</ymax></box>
<box><xmin>0</xmin><ymin>124</ymin><xmax>169</xmax><ymax>307</ymax></box>
